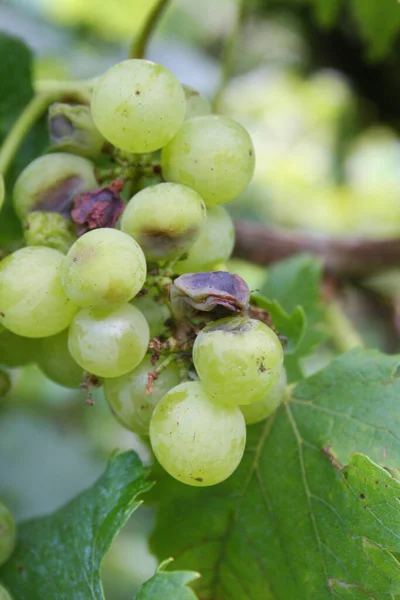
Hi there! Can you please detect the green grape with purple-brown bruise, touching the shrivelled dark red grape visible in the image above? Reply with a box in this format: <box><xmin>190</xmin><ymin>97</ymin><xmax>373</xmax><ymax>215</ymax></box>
<box><xmin>13</xmin><ymin>152</ymin><xmax>97</xmax><ymax>219</ymax></box>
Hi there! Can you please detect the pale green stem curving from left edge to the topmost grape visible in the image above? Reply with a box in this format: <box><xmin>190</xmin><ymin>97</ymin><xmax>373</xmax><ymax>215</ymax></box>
<box><xmin>0</xmin><ymin>80</ymin><xmax>94</xmax><ymax>175</ymax></box>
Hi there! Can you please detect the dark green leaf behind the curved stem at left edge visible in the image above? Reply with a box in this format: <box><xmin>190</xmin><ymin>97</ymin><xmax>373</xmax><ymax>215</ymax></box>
<box><xmin>0</xmin><ymin>32</ymin><xmax>48</xmax><ymax>246</ymax></box>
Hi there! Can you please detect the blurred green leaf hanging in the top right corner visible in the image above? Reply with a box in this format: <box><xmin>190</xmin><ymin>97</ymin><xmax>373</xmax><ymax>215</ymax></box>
<box><xmin>352</xmin><ymin>0</ymin><xmax>400</xmax><ymax>59</ymax></box>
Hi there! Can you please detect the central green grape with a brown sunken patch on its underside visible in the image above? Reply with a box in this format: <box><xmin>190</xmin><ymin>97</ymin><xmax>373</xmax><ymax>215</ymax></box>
<box><xmin>121</xmin><ymin>183</ymin><xmax>206</xmax><ymax>261</ymax></box>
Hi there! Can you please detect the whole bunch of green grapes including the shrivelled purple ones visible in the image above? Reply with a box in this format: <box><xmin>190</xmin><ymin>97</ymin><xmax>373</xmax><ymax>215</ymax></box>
<box><xmin>0</xmin><ymin>59</ymin><xmax>286</xmax><ymax>486</ymax></box>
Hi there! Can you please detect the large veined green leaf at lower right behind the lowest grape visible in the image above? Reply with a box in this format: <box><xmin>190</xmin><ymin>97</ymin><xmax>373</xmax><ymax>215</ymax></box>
<box><xmin>151</xmin><ymin>350</ymin><xmax>400</xmax><ymax>600</ymax></box>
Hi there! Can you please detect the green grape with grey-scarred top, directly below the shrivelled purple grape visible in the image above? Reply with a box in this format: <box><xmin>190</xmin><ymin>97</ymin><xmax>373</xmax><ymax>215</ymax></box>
<box><xmin>193</xmin><ymin>317</ymin><xmax>283</xmax><ymax>405</ymax></box>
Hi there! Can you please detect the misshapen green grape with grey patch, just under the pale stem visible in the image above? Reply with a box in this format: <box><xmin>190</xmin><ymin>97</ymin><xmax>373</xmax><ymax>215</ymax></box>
<box><xmin>48</xmin><ymin>102</ymin><xmax>105</xmax><ymax>157</ymax></box>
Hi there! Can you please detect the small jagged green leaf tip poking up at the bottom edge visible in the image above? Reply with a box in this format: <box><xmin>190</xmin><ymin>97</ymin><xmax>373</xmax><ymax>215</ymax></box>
<box><xmin>135</xmin><ymin>559</ymin><xmax>199</xmax><ymax>600</ymax></box>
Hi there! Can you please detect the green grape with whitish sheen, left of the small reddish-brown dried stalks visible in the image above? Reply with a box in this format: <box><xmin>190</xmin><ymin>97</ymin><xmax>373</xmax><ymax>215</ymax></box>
<box><xmin>68</xmin><ymin>304</ymin><xmax>150</xmax><ymax>377</ymax></box>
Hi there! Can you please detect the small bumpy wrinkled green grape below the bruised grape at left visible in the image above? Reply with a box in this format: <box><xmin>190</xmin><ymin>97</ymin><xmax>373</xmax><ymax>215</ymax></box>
<box><xmin>24</xmin><ymin>210</ymin><xmax>76</xmax><ymax>254</ymax></box>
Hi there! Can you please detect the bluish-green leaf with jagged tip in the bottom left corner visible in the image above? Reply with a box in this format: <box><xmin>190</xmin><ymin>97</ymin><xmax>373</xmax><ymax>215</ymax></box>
<box><xmin>0</xmin><ymin>452</ymin><xmax>152</xmax><ymax>600</ymax></box>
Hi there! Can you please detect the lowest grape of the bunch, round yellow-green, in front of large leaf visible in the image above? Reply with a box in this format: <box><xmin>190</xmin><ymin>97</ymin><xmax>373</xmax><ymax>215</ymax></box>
<box><xmin>150</xmin><ymin>381</ymin><xmax>246</xmax><ymax>486</ymax></box>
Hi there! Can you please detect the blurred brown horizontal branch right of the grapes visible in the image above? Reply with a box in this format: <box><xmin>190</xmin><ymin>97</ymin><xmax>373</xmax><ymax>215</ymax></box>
<box><xmin>234</xmin><ymin>220</ymin><xmax>400</xmax><ymax>277</ymax></box>
